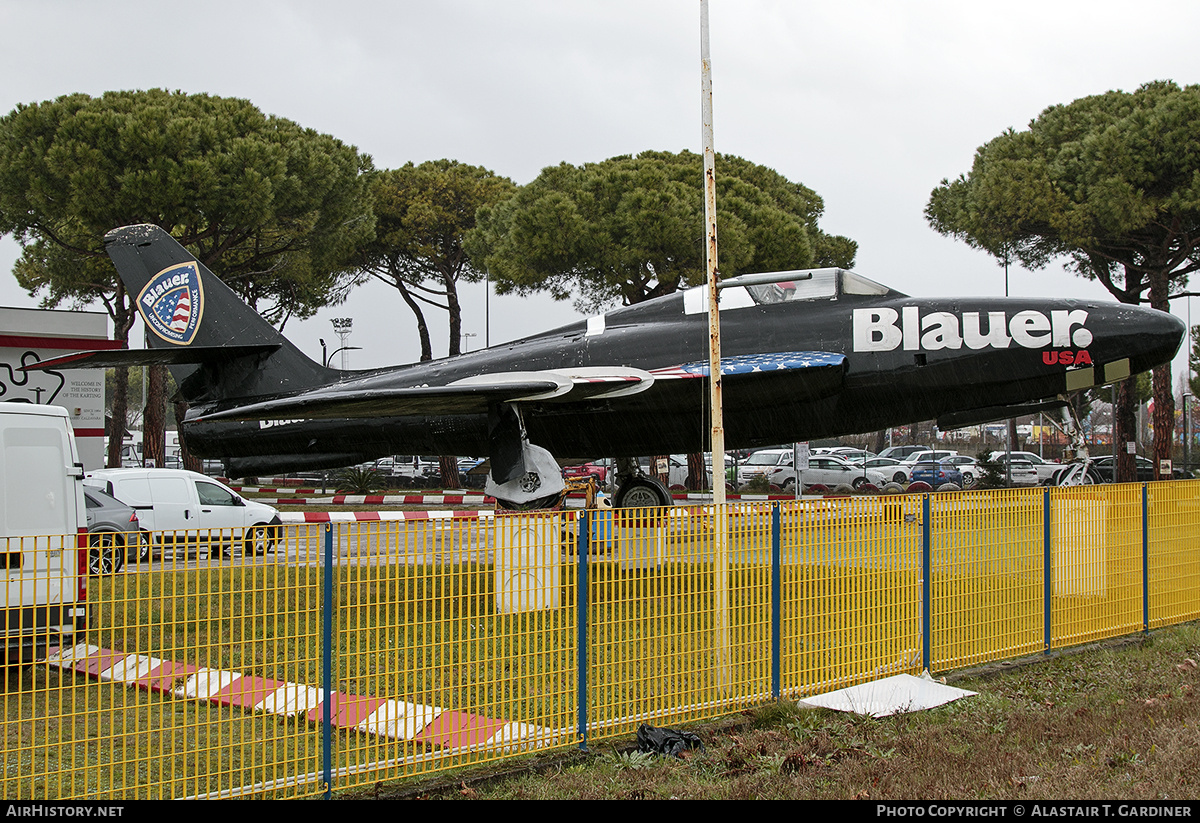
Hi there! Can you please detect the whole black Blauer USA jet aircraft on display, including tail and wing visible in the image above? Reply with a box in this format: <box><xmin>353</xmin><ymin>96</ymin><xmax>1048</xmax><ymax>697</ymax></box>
<box><xmin>28</xmin><ymin>226</ymin><xmax>1186</xmax><ymax>507</ymax></box>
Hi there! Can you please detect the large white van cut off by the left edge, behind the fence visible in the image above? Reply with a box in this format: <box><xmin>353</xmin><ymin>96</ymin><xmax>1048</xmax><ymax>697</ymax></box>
<box><xmin>0</xmin><ymin>403</ymin><xmax>88</xmax><ymax>662</ymax></box>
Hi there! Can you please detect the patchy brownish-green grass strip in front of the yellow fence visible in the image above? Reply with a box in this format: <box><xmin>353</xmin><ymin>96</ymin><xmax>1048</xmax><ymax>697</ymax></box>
<box><xmin>378</xmin><ymin>624</ymin><xmax>1200</xmax><ymax>801</ymax></box>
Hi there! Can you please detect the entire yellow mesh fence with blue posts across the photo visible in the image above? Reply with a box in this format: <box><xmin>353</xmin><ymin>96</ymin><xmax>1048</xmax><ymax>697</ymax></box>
<box><xmin>0</xmin><ymin>481</ymin><xmax>1200</xmax><ymax>799</ymax></box>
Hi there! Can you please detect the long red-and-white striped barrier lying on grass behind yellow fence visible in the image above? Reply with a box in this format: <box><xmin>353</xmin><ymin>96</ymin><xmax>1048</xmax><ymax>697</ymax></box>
<box><xmin>46</xmin><ymin>643</ymin><xmax>557</xmax><ymax>750</ymax></box>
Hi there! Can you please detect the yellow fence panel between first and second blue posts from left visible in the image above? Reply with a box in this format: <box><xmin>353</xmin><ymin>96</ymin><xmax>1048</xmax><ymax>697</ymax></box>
<box><xmin>334</xmin><ymin>512</ymin><xmax>576</xmax><ymax>787</ymax></box>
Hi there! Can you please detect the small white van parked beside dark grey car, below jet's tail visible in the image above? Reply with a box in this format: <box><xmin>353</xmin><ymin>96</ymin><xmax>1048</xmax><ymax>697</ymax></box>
<box><xmin>84</xmin><ymin>469</ymin><xmax>282</xmax><ymax>554</ymax></box>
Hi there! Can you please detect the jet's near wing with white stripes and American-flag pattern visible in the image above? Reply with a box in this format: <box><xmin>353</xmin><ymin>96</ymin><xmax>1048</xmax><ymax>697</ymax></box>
<box><xmin>198</xmin><ymin>352</ymin><xmax>846</xmax><ymax>420</ymax></box>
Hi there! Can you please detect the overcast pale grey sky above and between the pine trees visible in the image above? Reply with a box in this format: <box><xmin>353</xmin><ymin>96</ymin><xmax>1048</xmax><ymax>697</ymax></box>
<box><xmin>0</xmin><ymin>0</ymin><xmax>1200</xmax><ymax>370</ymax></box>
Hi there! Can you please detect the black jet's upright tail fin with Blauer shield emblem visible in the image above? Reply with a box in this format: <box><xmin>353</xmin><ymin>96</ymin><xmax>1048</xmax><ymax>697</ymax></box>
<box><xmin>104</xmin><ymin>224</ymin><xmax>337</xmax><ymax>406</ymax></box>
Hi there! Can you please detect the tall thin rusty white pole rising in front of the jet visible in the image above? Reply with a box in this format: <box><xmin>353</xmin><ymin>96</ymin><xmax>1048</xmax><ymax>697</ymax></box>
<box><xmin>700</xmin><ymin>0</ymin><xmax>732</xmax><ymax>692</ymax></box>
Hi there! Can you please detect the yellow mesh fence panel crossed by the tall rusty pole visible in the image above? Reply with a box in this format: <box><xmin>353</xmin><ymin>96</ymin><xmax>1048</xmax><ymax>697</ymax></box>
<box><xmin>588</xmin><ymin>506</ymin><xmax>770</xmax><ymax>738</ymax></box>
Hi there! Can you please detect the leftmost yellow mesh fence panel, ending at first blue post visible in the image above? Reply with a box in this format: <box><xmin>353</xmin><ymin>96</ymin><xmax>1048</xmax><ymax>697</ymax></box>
<box><xmin>0</xmin><ymin>529</ymin><xmax>320</xmax><ymax>799</ymax></box>
